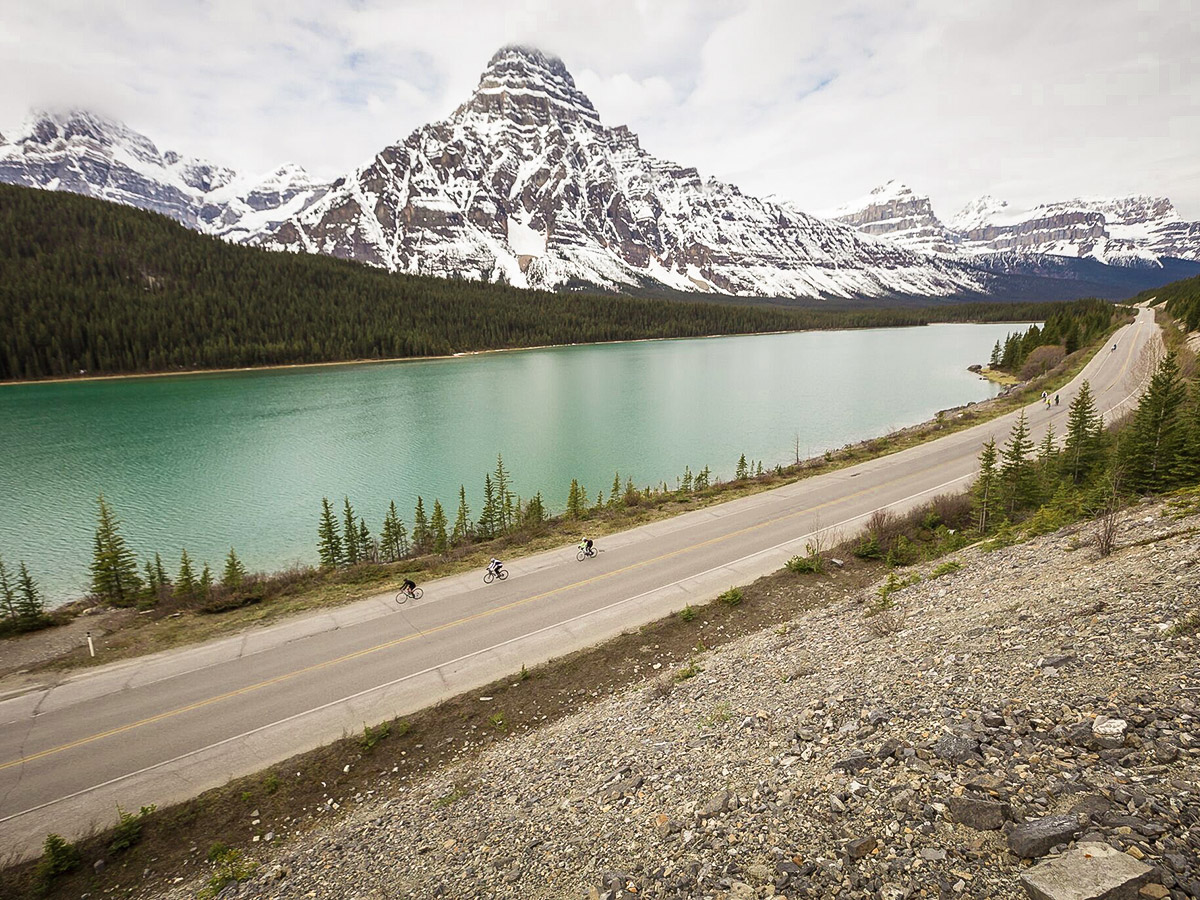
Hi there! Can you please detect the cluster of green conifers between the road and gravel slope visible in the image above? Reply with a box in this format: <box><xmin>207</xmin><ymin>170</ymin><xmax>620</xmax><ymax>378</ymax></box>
<box><xmin>971</xmin><ymin>354</ymin><xmax>1200</xmax><ymax>533</ymax></box>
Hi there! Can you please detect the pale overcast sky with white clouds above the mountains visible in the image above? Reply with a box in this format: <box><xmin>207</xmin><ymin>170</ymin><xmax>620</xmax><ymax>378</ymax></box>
<box><xmin>0</xmin><ymin>0</ymin><xmax>1200</xmax><ymax>220</ymax></box>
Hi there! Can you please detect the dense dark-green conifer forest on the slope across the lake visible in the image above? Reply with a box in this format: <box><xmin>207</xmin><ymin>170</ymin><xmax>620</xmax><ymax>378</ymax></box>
<box><xmin>0</xmin><ymin>185</ymin><xmax>1099</xmax><ymax>380</ymax></box>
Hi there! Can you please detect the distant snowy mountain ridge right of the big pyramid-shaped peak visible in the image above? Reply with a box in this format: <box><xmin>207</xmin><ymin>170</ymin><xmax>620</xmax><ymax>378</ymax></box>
<box><xmin>833</xmin><ymin>181</ymin><xmax>1200</xmax><ymax>272</ymax></box>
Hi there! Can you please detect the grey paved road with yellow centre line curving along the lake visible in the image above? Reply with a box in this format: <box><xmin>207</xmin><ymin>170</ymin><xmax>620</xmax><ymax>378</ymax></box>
<box><xmin>0</xmin><ymin>310</ymin><xmax>1160</xmax><ymax>856</ymax></box>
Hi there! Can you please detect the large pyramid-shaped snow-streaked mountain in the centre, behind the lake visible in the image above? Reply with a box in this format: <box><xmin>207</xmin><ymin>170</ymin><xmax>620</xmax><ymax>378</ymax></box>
<box><xmin>257</xmin><ymin>47</ymin><xmax>989</xmax><ymax>298</ymax></box>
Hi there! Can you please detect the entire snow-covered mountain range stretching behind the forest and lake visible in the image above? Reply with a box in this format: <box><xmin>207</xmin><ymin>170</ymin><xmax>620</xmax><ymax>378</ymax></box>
<box><xmin>0</xmin><ymin>47</ymin><xmax>1200</xmax><ymax>300</ymax></box>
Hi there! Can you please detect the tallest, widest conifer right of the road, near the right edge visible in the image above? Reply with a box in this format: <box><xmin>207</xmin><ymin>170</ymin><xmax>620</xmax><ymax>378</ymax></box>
<box><xmin>1123</xmin><ymin>353</ymin><xmax>1187</xmax><ymax>491</ymax></box>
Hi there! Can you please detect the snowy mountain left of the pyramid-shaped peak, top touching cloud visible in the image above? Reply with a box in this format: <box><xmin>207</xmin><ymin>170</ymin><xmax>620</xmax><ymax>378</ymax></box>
<box><xmin>0</xmin><ymin>109</ymin><xmax>324</xmax><ymax>239</ymax></box>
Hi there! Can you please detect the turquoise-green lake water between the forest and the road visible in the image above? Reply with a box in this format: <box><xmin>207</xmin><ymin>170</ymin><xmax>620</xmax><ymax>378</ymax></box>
<box><xmin>0</xmin><ymin>324</ymin><xmax>1024</xmax><ymax>602</ymax></box>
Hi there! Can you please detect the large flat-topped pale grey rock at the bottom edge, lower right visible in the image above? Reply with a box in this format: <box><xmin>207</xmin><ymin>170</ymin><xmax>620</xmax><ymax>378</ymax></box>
<box><xmin>1021</xmin><ymin>844</ymin><xmax>1154</xmax><ymax>900</ymax></box>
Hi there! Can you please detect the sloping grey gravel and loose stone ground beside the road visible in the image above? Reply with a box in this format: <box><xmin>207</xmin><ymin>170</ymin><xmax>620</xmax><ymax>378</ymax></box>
<box><xmin>154</xmin><ymin>504</ymin><xmax>1200</xmax><ymax>900</ymax></box>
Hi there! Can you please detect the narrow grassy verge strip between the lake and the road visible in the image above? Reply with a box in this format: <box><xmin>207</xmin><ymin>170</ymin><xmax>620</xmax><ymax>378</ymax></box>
<box><xmin>0</xmin><ymin>316</ymin><xmax>1132</xmax><ymax>676</ymax></box>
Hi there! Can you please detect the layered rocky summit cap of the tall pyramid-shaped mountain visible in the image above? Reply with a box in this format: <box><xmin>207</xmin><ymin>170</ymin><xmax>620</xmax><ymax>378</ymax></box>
<box><xmin>456</xmin><ymin>44</ymin><xmax>600</xmax><ymax>128</ymax></box>
